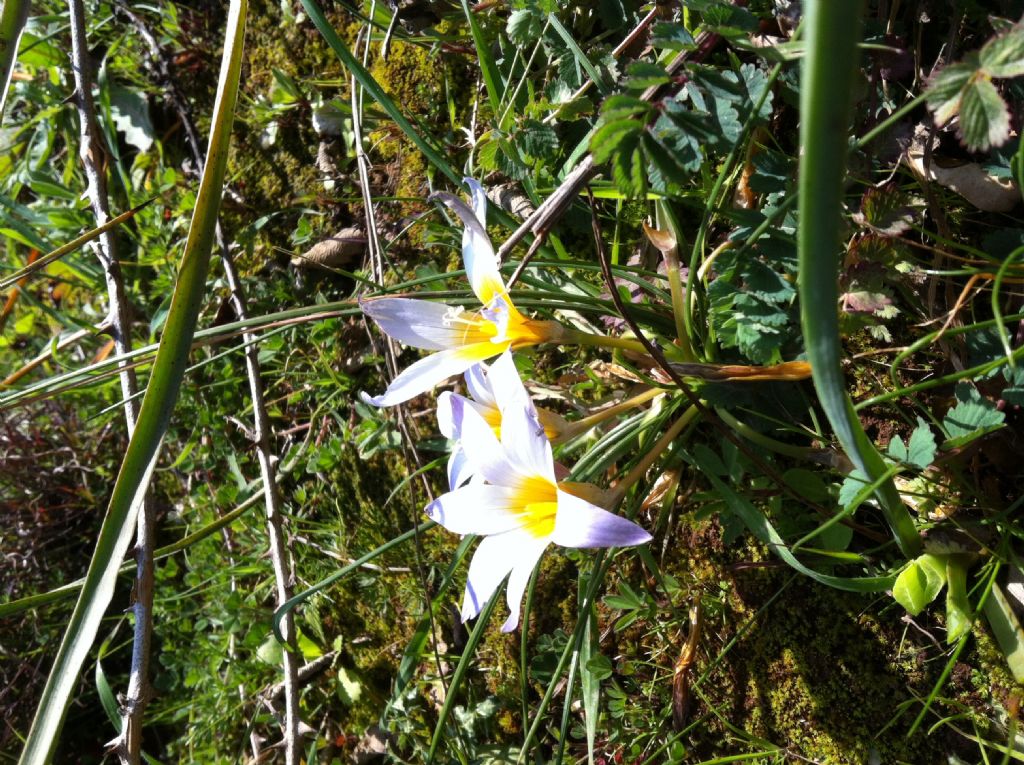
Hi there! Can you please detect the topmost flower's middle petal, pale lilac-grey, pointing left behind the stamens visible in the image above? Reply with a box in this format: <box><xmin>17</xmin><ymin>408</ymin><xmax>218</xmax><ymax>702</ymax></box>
<box><xmin>359</xmin><ymin>297</ymin><xmax>490</xmax><ymax>352</ymax></box>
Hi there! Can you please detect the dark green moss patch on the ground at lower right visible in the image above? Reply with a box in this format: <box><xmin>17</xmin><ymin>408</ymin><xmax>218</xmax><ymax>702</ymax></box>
<box><xmin>655</xmin><ymin>514</ymin><xmax>980</xmax><ymax>764</ymax></box>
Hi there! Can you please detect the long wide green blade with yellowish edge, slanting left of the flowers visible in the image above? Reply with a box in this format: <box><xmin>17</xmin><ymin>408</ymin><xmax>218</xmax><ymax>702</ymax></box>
<box><xmin>20</xmin><ymin>0</ymin><xmax>247</xmax><ymax>765</ymax></box>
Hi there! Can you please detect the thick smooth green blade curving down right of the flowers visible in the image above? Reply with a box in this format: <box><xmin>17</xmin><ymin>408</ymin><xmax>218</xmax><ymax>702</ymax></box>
<box><xmin>798</xmin><ymin>0</ymin><xmax>921</xmax><ymax>557</ymax></box>
